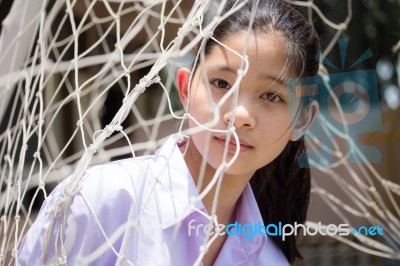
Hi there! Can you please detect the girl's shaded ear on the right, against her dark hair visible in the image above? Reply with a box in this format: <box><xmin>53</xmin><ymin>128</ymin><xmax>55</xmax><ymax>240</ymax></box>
<box><xmin>290</xmin><ymin>101</ymin><xmax>319</xmax><ymax>141</ymax></box>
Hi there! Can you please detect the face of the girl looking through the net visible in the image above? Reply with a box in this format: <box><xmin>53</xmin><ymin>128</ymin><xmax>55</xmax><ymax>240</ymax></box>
<box><xmin>178</xmin><ymin>32</ymin><xmax>300</xmax><ymax>179</ymax></box>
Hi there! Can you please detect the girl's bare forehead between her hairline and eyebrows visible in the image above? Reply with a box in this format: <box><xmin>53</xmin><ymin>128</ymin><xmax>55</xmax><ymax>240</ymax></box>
<box><xmin>205</xmin><ymin>31</ymin><xmax>290</xmax><ymax>79</ymax></box>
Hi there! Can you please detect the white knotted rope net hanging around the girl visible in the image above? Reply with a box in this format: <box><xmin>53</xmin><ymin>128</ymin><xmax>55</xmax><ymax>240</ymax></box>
<box><xmin>0</xmin><ymin>0</ymin><xmax>400</xmax><ymax>265</ymax></box>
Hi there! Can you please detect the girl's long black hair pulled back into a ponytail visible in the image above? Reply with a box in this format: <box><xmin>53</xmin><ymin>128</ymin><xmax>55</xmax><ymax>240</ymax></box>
<box><xmin>198</xmin><ymin>0</ymin><xmax>319</xmax><ymax>263</ymax></box>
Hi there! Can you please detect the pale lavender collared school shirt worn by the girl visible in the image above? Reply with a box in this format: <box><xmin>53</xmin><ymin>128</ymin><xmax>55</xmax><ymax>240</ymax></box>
<box><xmin>17</xmin><ymin>136</ymin><xmax>289</xmax><ymax>266</ymax></box>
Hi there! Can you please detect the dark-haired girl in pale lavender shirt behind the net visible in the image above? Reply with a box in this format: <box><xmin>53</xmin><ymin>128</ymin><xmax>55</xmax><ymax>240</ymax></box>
<box><xmin>17</xmin><ymin>0</ymin><xmax>319</xmax><ymax>265</ymax></box>
